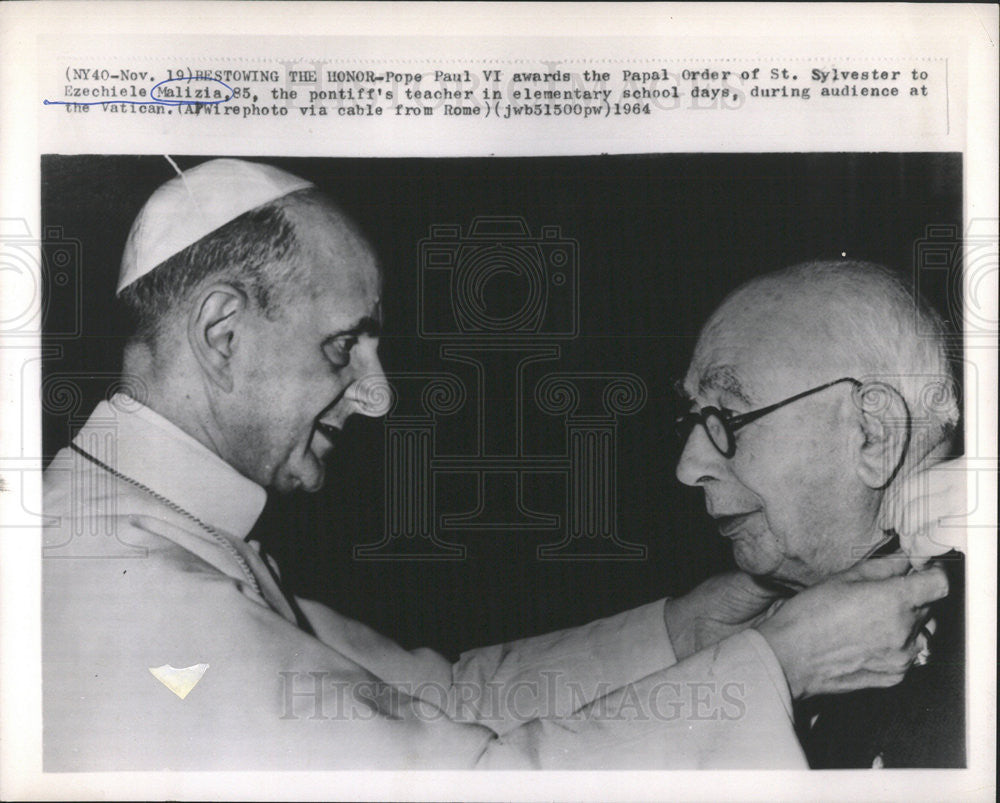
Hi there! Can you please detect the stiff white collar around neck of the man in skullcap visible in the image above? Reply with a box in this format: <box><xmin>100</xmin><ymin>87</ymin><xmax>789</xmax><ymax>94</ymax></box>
<box><xmin>73</xmin><ymin>393</ymin><xmax>267</xmax><ymax>538</ymax></box>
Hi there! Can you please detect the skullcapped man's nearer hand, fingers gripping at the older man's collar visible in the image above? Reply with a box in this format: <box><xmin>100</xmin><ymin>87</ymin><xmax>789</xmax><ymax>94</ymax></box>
<box><xmin>757</xmin><ymin>553</ymin><xmax>948</xmax><ymax>698</ymax></box>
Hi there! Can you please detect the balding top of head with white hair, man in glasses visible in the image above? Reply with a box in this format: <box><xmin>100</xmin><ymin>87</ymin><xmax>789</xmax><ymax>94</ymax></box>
<box><xmin>692</xmin><ymin>260</ymin><xmax>959</xmax><ymax>457</ymax></box>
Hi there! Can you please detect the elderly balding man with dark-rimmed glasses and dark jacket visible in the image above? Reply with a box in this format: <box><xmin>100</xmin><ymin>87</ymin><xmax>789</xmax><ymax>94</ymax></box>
<box><xmin>676</xmin><ymin>260</ymin><xmax>964</xmax><ymax>767</ymax></box>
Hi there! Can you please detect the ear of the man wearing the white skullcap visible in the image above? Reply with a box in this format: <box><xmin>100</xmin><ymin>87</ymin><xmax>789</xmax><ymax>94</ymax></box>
<box><xmin>187</xmin><ymin>282</ymin><xmax>247</xmax><ymax>393</ymax></box>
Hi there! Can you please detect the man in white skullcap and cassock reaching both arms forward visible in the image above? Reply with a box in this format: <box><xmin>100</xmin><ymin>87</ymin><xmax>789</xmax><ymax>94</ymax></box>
<box><xmin>43</xmin><ymin>159</ymin><xmax>947</xmax><ymax>771</ymax></box>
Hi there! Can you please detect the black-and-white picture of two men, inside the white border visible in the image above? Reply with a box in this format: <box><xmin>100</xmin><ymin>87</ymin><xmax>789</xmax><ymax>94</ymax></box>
<box><xmin>42</xmin><ymin>153</ymin><xmax>966</xmax><ymax>771</ymax></box>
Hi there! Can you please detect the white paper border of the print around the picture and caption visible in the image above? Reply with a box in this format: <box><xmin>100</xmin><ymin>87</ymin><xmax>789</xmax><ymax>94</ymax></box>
<box><xmin>0</xmin><ymin>2</ymin><xmax>998</xmax><ymax>800</ymax></box>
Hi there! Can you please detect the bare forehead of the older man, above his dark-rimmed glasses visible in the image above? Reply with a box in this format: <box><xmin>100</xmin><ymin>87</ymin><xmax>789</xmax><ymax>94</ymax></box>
<box><xmin>684</xmin><ymin>287</ymin><xmax>836</xmax><ymax>406</ymax></box>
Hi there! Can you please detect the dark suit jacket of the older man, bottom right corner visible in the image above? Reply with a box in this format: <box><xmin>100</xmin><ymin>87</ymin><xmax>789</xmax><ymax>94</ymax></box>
<box><xmin>796</xmin><ymin>552</ymin><xmax>966</xmax><ymax>769</ymax></box>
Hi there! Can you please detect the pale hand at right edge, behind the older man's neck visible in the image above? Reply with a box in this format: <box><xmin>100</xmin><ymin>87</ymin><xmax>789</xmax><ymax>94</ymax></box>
<box><xmin>880</xmin><ymin>458</ymin><xmax>969</xmax><ymax>568</ymax></box>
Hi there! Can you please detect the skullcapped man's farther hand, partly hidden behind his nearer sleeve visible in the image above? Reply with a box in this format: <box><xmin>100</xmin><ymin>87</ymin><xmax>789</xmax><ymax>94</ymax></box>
<box><xmin>663</xmin><ymin>572</ymin><xmax>781</xmax><ymax>661</ymax></box>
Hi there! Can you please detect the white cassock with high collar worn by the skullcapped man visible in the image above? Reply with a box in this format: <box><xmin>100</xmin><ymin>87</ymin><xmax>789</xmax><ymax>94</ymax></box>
<box><xmin>42</xmin><ymin>396</ymin><xmax>806</xmax><ymax>771</ymax></box>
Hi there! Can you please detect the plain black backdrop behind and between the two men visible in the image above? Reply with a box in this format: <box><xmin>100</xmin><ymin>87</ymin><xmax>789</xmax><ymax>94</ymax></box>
<box><xmin>42</xmin><ymin>154</ymin><xmax>962</xmax><ymax>657</ymax></box>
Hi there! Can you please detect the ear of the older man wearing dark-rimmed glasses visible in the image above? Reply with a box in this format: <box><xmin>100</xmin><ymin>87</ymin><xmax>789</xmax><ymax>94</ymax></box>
<box><xmin>855</xmin><ymin>382</ymin><xmax>912</xmax><ymax>490</ymax></box>
